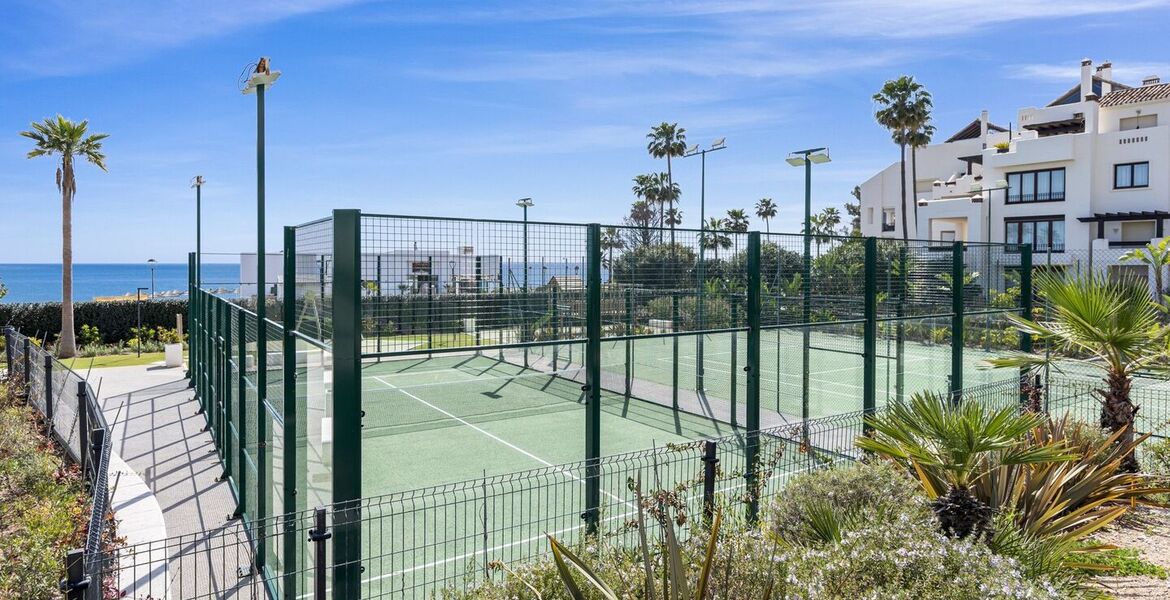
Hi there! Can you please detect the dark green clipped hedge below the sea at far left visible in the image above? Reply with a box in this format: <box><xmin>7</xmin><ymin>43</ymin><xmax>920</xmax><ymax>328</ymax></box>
<box><xmin>0</xmin><ymin>299</ymin><xmax>187</xmax><ymax>344</ymax></box>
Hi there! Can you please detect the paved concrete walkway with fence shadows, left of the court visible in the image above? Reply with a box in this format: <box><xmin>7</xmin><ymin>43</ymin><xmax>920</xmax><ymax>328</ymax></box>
<box><xmin>89</xmin><ymin>365</ymin><xmax>263</xmax><ymax>599</ymax></box>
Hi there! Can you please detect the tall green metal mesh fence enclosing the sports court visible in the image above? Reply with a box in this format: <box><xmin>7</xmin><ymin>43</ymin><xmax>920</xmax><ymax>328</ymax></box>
<box><xmin>190</xmin><ymin>211</ymin><xmax>1048</xmax><ymax>598</ymax></box>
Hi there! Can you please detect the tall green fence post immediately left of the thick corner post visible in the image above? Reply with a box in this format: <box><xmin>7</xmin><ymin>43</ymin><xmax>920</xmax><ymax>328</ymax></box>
<box><xmin>281</xmin><ymin>227</ymin><xmax>299</xmax><ymax>600</ymax></box>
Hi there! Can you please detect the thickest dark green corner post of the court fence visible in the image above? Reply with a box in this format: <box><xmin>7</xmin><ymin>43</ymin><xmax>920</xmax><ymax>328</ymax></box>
<box><xmin>332</xmin><ymin>209</ymin><xmax>362</xmax><ymax>598</ymax></box>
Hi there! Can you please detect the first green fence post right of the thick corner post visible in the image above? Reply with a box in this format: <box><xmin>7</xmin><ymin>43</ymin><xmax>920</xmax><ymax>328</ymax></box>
<box><xmin>583</xmin><ymin>223</ymin><xmax>601</xmax><ymax>535</ymax></box>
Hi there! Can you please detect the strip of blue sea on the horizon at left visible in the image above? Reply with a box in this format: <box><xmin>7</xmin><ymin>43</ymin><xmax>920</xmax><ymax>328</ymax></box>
<box><xmin>0</xmin><ymin>263</ymin><xmax>240</xmax><ymax>304</ymax></box>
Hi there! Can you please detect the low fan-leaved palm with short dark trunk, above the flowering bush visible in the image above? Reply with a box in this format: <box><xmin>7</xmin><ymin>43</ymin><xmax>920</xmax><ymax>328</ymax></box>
<box><xmin>856</xmin><ymin>392</ymin><xmax>1075</xmax><ymax>538</ymax></box>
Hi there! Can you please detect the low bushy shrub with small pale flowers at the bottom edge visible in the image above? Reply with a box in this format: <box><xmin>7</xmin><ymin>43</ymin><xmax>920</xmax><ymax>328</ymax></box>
<box><xmin>445</xmin><ymin>464</ymin><xmax>1068</xmax><ymax>600</ymax></box>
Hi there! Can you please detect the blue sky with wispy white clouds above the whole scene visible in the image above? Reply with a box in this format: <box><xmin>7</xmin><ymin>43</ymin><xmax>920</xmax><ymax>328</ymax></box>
<box><xmin>0</xmin><ymin>0</ymin><xmax>1170</xmax><ymax>263</ymax></box>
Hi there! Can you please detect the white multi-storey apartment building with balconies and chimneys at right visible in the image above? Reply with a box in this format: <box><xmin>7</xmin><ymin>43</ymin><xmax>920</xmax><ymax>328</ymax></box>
<box><xmin>861</xmin><ymin>60</ymin><xmax>1170</xmax><ymax>274</ymax></box>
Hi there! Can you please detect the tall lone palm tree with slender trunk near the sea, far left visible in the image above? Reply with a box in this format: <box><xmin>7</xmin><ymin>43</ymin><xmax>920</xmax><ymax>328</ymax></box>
<box><xmin>20</xmin><ymin>115</ymin><xmax>110</xmax><ymax>358</ymax></box>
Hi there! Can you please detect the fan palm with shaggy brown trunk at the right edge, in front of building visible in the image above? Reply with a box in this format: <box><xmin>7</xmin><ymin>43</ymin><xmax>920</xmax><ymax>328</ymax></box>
<box><xmin>985</xmin><ymin>273</ymin><xmax>1170</xmax><ymax>473</ymax></box>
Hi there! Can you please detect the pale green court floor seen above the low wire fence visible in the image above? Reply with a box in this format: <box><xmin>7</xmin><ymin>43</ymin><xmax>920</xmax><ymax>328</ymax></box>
<box><xmin>362</xmin><ymin>352</ymin><xmax>734</xmax><ymax>496</ymax></box>
